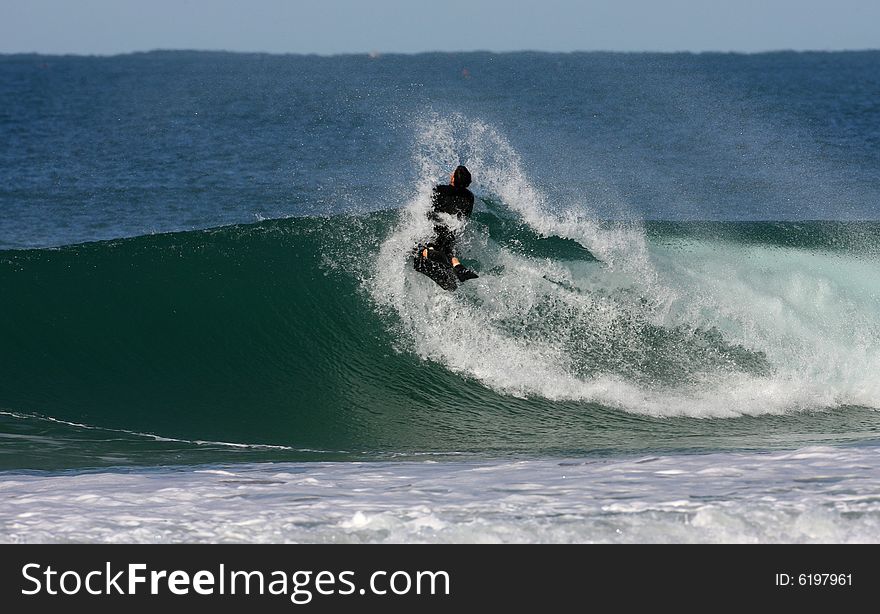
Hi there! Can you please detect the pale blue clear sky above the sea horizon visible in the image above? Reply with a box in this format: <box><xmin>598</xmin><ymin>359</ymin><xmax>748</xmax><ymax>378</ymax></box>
<box><xmin>0</xmin><ymin>0</ymin><xmax>880</xmax><ymax>54</ymax></box>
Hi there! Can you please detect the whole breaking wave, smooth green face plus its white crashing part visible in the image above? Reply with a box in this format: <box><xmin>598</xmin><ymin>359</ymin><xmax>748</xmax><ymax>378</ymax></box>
<box><xmin>0</xmin><ymin>214</ymin><xmax>880</xmax><ymax>466</ymax></box>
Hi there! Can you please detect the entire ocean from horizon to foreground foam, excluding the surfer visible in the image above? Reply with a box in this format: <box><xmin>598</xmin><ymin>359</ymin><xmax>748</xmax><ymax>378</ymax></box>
<box><xmin>0</xmin><ymin>51</ymin><xmax>880</xmax><ymax>543</ymax></box>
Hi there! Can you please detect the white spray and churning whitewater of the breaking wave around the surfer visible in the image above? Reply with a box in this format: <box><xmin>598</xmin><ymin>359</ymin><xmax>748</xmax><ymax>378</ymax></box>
<box><xmin>369</xmin><ymin>115</ymin><xmax>880</xmax><ymax>417</ymax></box>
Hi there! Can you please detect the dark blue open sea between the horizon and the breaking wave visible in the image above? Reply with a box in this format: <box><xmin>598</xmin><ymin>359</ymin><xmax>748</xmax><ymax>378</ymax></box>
<box><xmin>0</xmin><ymin>51</ymin><xmax>880</xmax><ymax>247</ymax></box>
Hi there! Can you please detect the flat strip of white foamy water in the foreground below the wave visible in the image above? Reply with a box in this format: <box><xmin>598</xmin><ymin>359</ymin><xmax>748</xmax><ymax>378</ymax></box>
<box><xmin>0</xmin><ymin>447</ymin><xmax>880</xmax><ymax>543</ymax></box>
